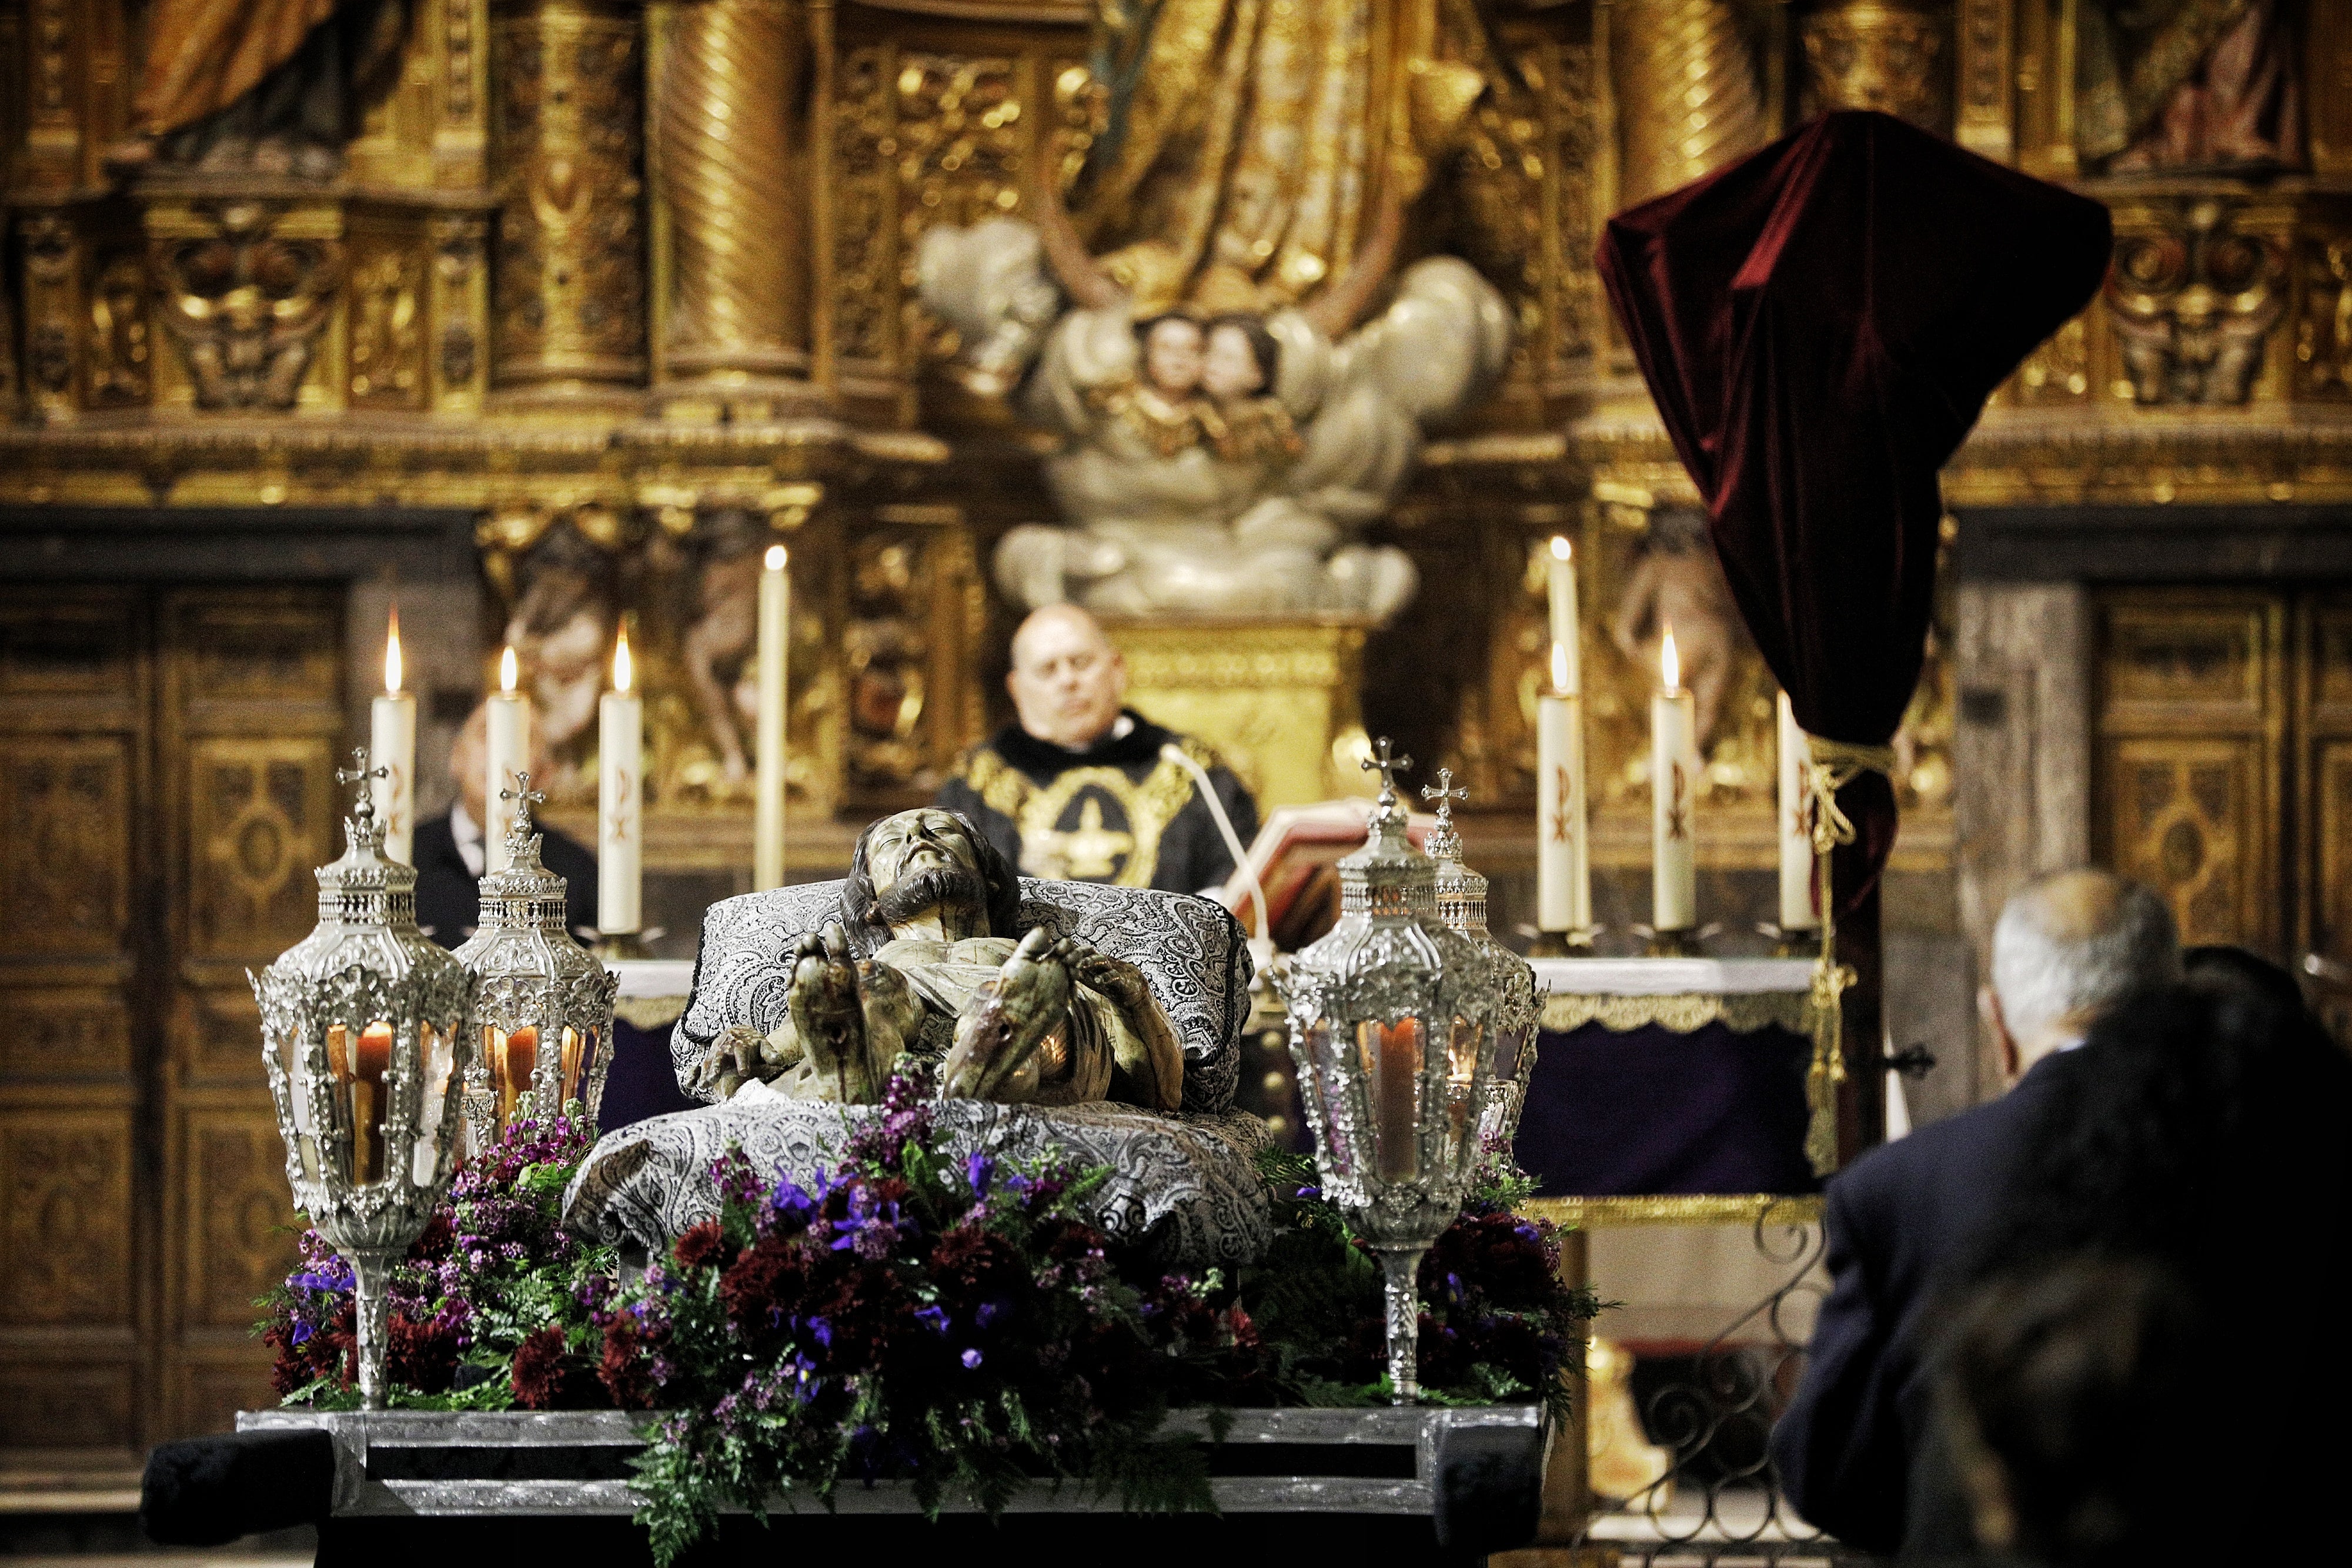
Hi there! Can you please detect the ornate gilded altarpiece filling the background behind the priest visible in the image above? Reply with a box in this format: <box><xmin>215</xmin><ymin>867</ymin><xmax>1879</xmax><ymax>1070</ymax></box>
<box><xmin>0</xmin><ymin>0</ymin><xmax>2352</xmax><ymax>1462</ymax></box>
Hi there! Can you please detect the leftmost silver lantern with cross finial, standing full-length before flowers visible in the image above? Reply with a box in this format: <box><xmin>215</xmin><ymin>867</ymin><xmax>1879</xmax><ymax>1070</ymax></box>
<box><xmin>245</xmin><ymin>750</ymin><xmax>473</xmax><ymax>1410</ymax></box>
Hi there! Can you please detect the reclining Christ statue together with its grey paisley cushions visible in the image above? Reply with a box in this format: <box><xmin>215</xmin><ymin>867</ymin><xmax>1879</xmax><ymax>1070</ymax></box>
<box><xmin>564</xmin><ymin>811</ymin><xmax>1268</xmax><ymax>1265</ymax></box>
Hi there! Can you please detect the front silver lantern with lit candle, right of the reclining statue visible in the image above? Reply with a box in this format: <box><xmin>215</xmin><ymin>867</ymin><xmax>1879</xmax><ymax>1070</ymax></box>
<box><xmin>1277</xmin><ymin>738</ymin><xmax>1501</xmax><ymax>1403</ymax></box>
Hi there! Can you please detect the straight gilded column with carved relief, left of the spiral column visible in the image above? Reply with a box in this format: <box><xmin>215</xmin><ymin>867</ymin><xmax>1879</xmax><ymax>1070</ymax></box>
<box><xmin>492</xmin><ymin>0</ymin><xmax>644</xmax><ymax>395</ymax></box>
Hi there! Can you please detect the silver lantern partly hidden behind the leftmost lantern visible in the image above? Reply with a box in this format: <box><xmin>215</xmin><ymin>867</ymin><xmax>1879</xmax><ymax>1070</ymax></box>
<box><xmin>456</xmin><ymin>774</ymin><xmax>621</xmax><ymax>1149</ymax></box>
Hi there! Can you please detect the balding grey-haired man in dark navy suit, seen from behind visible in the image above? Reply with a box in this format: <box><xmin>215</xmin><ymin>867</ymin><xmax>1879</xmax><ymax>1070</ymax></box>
<box><xmin>1771</xmin><ymin>870</ymin><xmax>2180</xmax><ymax>1556</ymax></box>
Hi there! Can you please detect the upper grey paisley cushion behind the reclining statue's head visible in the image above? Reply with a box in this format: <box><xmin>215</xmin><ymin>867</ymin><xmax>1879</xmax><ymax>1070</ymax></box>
<box><xmin>670</xmin><ymin>877</ymin><xmax>1251</xmax><ymax>1114</ymax></box>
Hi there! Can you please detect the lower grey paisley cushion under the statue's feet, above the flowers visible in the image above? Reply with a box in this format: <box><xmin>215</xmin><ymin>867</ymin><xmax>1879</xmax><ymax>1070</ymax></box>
<box><xmin>564</xmin><ymin>1093</ymin><xmax>1270</xmax><ymax>1267</ymax></box>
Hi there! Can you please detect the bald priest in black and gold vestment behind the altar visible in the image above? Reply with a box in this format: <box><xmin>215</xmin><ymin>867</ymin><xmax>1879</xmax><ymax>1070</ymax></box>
<box><xmin>936</xmin><ymin>604</ymin><xmax>1258</xmax><ymax>893</ymax></box>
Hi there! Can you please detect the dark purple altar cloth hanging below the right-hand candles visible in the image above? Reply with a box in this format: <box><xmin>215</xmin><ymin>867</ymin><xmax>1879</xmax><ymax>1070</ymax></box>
<box><xmin>1512</xmin><ymin>1022</ymin><xmax>1820</xmax><ymax>1196</ymax></box>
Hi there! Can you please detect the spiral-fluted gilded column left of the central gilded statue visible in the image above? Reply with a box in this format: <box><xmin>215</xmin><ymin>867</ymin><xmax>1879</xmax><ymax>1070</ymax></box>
<box><xmin>649</xmin><ymin>0</ymin><xmax>809</xmax><ymax>402</ymax></box>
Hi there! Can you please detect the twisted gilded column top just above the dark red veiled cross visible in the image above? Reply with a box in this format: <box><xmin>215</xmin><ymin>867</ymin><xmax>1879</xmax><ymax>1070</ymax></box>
<box><xmin>1611</xmin><ymin>0</ymin><xmax>1769</xmax><ymax>207</ymax></box>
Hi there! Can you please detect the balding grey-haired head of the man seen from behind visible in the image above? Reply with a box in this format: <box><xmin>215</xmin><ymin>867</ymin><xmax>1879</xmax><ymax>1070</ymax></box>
<box><xmin>1983</xmin><ymin>870</ymin><xmax>2180</xmax><ymax>1076</ymax></box>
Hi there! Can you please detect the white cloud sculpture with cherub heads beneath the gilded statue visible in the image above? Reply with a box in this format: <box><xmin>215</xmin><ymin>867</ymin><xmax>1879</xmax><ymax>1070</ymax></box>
<box><xmin>920</xmin><ymin>185</ymin><xmax>1510</xmax><ymax>621</ymax></box>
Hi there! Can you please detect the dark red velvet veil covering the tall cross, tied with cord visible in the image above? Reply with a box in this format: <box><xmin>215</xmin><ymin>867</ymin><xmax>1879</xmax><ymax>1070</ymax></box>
<box><xmin>1599</xmin><ymin>113</ymin><xmax>2112</xmax><ymax>900</ymax></box>
